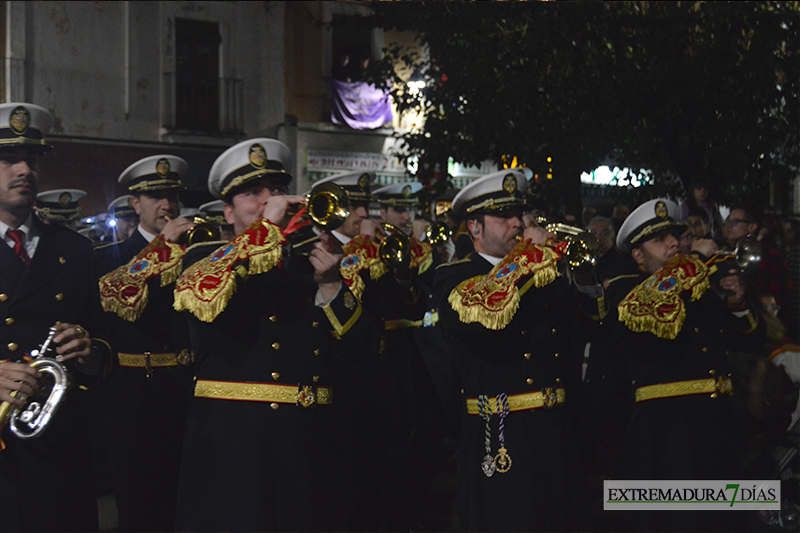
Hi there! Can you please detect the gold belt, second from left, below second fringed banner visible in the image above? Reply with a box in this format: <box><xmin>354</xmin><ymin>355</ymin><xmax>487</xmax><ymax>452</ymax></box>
<box><xmin>194</xmin><ymin>379</ymin><xmax>333</xmax><ymax>406</ymax></box>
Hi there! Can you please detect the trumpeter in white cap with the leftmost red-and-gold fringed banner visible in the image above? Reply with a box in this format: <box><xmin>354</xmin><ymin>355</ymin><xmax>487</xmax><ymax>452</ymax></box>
<box><xmin>95</xmin><ymin>155</ymin><xmax>192</xmax><ymax>531</ymax></box>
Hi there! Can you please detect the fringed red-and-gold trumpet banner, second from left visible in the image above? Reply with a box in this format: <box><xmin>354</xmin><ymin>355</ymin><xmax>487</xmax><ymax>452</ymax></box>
<box><xmin>173</xmin><ymin>219</ymin><xmax>286</xmax><ymax>322</ymax></box>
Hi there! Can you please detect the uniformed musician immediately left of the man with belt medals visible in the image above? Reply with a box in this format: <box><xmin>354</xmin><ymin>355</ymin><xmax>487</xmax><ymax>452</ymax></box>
<box><xmin>342</xmin><ymin>183</ymin><xmax>458</xmax><ymax>531</ymax></box>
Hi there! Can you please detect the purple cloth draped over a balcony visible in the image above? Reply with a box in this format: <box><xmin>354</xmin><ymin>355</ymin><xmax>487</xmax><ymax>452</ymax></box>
<box><xmin>331</xmin><ymin>80</ymin><xmax>392</xmax><ymax>130</ymax></box>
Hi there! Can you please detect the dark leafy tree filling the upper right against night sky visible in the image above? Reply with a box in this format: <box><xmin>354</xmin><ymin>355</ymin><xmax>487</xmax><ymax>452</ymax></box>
<box><xmin>371</xmin><ymin>2</ymin><xmax>800</xmax><ymax>212</ymax></box>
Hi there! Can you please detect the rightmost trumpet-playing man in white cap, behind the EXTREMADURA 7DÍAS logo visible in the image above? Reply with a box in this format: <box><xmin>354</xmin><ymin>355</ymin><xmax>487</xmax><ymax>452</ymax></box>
<box><xmin>589</xmin><ymin>198</ymin><xmax>764</xmax><ymax>531</ymax></box>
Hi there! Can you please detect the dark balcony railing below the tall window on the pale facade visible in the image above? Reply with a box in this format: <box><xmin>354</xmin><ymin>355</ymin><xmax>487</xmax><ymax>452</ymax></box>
<box><xmin>162</xmin><ymin>72</ymin><xmax>244</xmax><ymax>134</ymax></box>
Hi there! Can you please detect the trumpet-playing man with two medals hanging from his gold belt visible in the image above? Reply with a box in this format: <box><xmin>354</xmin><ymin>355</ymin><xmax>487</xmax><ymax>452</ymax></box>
<box><xmin>434</xmin><ymin>168</ymin><xmax>580</xmax><ymax>531</ymax></box>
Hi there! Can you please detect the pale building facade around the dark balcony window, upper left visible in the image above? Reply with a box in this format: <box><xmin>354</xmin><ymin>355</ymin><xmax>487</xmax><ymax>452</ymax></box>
<box><xmin>4</xmin><ymin>1</ymin><xmax>284</xmax><ymax>145</ymax></box>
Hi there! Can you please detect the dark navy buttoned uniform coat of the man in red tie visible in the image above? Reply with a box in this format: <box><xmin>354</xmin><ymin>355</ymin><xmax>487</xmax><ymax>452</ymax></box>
<box><xmin>0</xmin><ymin>218</ymin><xmax>113</xmax><ymax>531</ymax></box>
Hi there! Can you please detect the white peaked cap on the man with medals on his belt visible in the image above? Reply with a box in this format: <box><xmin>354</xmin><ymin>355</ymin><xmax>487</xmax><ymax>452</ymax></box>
<box><xmin>452</xmin><ymin>168</ymin><xmax>531</xmax><ymax>216</ymax></box>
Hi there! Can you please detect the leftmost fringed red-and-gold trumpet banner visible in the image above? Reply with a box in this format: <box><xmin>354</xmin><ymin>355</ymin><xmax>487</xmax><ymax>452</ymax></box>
<box><xmin>100</xmin><ymin>235</ymin><xmax>183</xmax><ymax>322</ymax></box>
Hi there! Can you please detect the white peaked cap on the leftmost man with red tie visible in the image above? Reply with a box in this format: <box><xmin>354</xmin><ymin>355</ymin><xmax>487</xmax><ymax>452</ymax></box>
<box><xmin>0</xmin><ymin>102</ymin><xmax>53</xmax><ymax>154</ymax></box>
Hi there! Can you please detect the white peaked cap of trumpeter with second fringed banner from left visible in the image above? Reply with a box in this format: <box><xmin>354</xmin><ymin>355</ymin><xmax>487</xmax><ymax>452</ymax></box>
<box><xmin>208</xmin><ymin>138</ymin><xmax>292</xmax><ymax>199</ymax></box>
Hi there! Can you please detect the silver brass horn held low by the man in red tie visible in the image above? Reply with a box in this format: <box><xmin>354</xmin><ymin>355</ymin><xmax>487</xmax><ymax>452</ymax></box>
<box><xmin>0</xmin><ymin>327</ymin><xmax>69</xmax><ymax>439</ymax></box>
